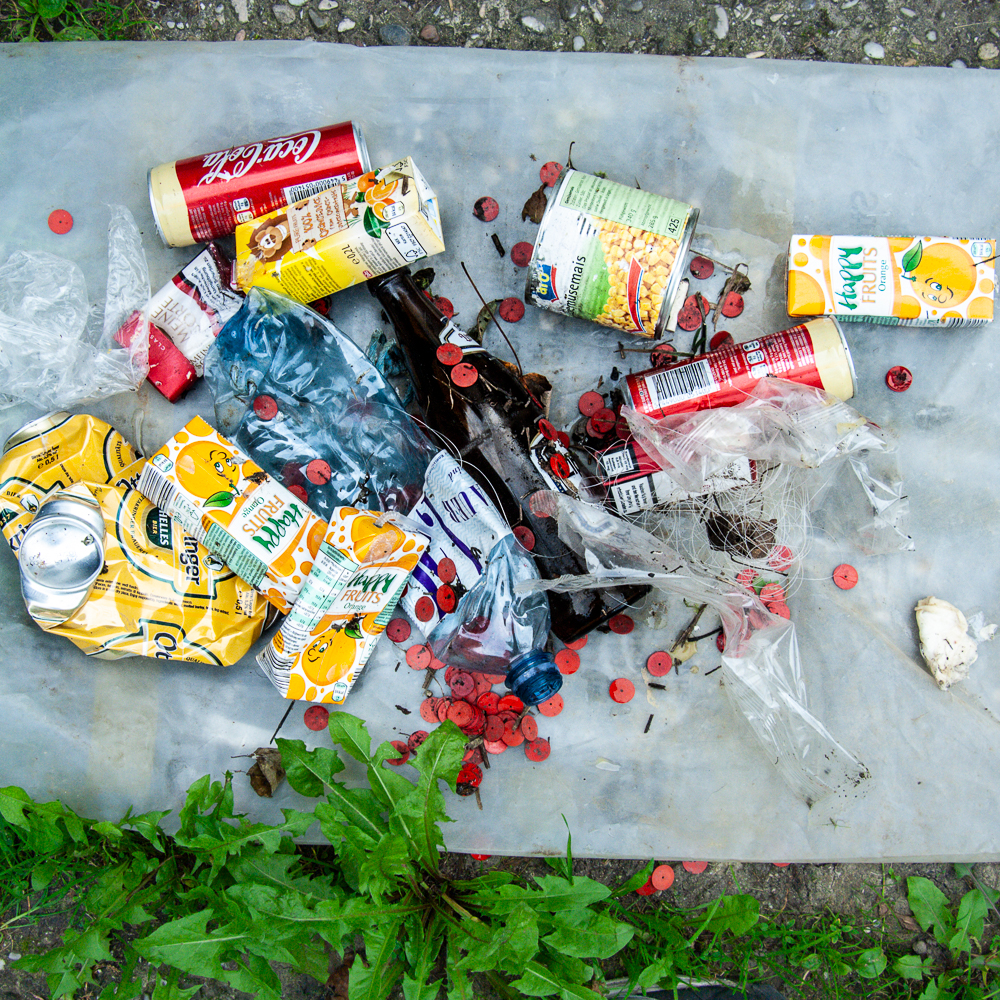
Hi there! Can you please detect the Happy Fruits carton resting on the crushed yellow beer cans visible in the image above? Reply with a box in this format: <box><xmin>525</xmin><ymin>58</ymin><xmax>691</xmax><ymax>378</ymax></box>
<box><xmin>138</xmin><ymin>417</ymin><xmax>324</xmax><ymax>613</ymax></box>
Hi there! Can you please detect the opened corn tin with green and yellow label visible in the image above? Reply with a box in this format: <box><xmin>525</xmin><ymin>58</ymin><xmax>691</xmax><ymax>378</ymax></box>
<box><xmin>524</xmin><ymin>168</ymin><xmax>698</xmax><ymax>337</ymax></box>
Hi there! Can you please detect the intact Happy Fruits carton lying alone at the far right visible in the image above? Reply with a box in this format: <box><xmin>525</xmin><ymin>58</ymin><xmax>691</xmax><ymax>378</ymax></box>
<box><xmin>788</xmin><ymin>235</ymin><xmax>996</xmax><ymax>326</ymax></box>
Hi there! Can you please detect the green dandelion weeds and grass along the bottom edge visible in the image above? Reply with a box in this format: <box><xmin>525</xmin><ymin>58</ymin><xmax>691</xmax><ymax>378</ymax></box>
<box><xmin>0</xmin><ymin>712</ymin><xmax>1000</xmax><ymax>1000</ymax></box>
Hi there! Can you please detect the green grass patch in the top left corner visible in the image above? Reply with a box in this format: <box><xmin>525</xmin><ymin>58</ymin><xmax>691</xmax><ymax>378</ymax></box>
<box><xmin>0</xmin><ymin>0</ymin><xmax>151</xmax><ymax>42</ymax></box>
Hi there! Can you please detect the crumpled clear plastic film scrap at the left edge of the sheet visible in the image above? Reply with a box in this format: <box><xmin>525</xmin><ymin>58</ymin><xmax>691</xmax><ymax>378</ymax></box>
<box><xmin>0</xmin><ymin>205</ymin><xmax>149</xmax><ymax>409</ymax></box>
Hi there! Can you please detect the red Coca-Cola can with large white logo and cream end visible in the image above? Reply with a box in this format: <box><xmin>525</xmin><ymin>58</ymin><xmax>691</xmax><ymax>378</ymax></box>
<box><xmin>149</xmin><ymin>122</ymin><xmax>371</xmax><ymax>247</ymax></box>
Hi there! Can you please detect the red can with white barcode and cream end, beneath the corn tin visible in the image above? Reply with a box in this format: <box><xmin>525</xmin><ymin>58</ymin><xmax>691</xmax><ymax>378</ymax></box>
<box><xmin>625</xmin><ymin>318</ymin><xmax>855</xmax><ymax>417</ymax></box>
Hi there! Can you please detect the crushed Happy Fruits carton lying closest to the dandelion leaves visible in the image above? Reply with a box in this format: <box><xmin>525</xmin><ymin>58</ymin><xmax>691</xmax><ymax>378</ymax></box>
<box><xmin>257</xmin><ymin>507</ymin><xmax>428</xmax><ymax>705</ymax></box>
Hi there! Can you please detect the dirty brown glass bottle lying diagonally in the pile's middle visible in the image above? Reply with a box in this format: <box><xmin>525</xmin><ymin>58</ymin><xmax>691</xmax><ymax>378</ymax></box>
<box><xmin>368</xmin><ymin>268</ymin><xmax>648</xmax><ymax>642</ymax></box>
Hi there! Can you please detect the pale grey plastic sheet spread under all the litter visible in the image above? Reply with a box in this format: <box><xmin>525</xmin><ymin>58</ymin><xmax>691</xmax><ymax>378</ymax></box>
<box><xmin>0</xmin><ymin>42</ymin><xmax>1000</xmax><ymax>861</ymax></box>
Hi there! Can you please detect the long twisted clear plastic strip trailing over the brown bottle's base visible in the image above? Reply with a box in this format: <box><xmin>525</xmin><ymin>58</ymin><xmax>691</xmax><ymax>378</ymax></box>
<box><xmin>517</xmin><ymin>493</ymin><xmax>872</xmax><ymax>806</ymax></box>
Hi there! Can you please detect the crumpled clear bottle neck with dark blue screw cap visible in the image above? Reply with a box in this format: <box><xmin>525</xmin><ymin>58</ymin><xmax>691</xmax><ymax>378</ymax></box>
<box><xmin>427</xmin><ymin>535</ymin><xmax>562</xmax><ymax>705</ymax></box>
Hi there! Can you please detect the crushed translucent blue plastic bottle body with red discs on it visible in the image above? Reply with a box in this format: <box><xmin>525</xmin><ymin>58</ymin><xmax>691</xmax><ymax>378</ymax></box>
<box><xmin>205</xmin><ymin>288</ymin><xmax>435</xmax><ymax>520</ymax></box>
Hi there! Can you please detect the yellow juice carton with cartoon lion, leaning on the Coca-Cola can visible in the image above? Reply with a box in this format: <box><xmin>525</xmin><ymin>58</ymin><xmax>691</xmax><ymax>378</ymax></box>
<box><xmin>236</xmin><ymin>157</ymin><xmax>444</xmax><ymax>302</ymax></box>
